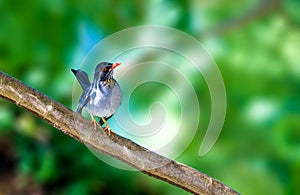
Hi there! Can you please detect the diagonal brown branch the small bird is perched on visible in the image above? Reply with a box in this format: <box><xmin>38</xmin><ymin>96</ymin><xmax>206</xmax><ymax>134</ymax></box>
<box><xmin>0</xmin><ymin>71</ymin><xmax>238</xmax><ymax>194</ymax></box>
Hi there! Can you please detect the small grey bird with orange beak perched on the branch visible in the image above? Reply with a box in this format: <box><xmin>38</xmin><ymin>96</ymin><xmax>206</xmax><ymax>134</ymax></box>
<box><xmin>71</xmin><ymin>62</ymin><xmax>122</xmax><ymax>135</ymax></box>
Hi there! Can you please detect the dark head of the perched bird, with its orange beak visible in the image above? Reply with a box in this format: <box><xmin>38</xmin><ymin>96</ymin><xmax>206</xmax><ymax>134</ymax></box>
<box><xmin>94</xmin><ymin>62</ymin><xmax>121</xmax><ymax>81</ymax></box>
